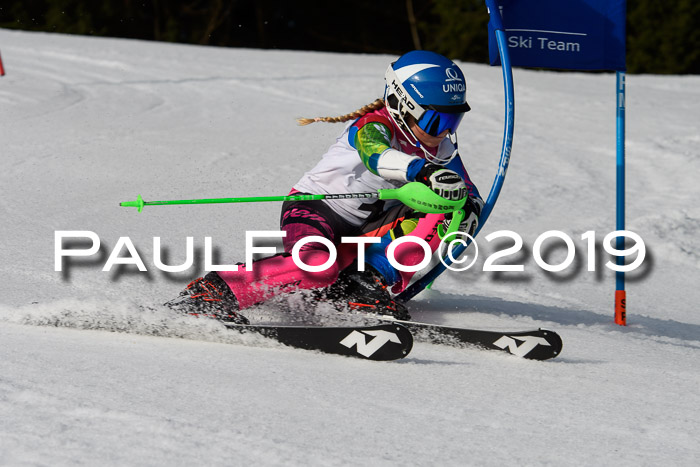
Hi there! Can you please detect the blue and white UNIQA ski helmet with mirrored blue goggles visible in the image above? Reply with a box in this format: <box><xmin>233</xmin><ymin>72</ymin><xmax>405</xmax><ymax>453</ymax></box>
<box><xmin>384</xmin><ymin>50</ymin><xmax>470</xmax><ymax>162</ymax></box>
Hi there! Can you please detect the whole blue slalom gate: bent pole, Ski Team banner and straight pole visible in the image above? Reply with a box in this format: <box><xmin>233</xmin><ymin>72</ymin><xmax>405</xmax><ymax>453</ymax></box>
<box><xmin>397</xmin><ymin>0</ymin><xmax>627</xmax><ymax>325</ymax></box>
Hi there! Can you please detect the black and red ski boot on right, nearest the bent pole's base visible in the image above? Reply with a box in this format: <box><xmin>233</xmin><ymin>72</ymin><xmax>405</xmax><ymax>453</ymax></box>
<box><xmin>325</xmin><ymin>264</ymin><xmax>411</xmax><ymax>320</ymax></box>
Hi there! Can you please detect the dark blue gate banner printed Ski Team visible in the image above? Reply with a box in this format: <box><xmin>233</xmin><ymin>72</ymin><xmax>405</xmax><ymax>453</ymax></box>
<box><xmin>489</xmin><ymin>0</ymin><xmax>627</xmax><ymax>71</ymax></box>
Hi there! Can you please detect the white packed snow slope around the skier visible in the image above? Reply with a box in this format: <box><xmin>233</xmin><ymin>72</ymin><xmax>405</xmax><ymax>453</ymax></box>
<box><xmin>0</xmin><ymin>30</ymin><xmax>700</xmax><ymax>465</ymax></box>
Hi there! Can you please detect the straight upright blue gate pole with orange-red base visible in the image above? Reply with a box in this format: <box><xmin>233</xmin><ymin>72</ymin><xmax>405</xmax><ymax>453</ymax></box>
<box><xmin>615</xmin><ymin>71</ymin><xmax>627</xmax><ymax>326</ymax></box>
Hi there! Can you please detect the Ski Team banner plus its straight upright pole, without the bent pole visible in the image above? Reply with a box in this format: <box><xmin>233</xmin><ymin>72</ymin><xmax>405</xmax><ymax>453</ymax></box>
<box><xmin>486</xmin><ymin>0</ymin><xmax>627</xmax><ymax>326</ymax></box>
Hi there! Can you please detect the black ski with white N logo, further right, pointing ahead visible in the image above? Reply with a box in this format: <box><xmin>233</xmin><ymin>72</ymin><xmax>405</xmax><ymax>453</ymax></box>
<box><xmin>380</xmin><ymin>320</ymin><xmax>563</xmax><ymax>360</ymax></box>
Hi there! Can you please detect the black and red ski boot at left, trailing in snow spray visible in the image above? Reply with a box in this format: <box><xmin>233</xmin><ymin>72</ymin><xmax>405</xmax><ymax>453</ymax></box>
<box><xmin>165</xmin><ymin>271</ymin><xmax>250</xmax><ymax>324</ymax></box>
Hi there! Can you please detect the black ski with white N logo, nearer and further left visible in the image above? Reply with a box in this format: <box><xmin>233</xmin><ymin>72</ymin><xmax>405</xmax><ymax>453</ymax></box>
<box><xmin>224</xmin><ymin>323</ymin><xmax>413</xmax><ymax>361</ymax></box>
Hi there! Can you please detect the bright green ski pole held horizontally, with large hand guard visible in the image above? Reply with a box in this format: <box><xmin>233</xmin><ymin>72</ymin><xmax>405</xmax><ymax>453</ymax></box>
<box><xmin>119</xmin><ymin>182</ymin><xmax>466</xmax><ymax>217</ymax></box>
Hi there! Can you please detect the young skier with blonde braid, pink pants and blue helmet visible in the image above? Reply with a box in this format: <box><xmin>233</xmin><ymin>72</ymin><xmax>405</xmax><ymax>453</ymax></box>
<box><xmin>166</xmin><ymin>51</ymin><xmax>484</xmax><ymax>324</ymax></box>
